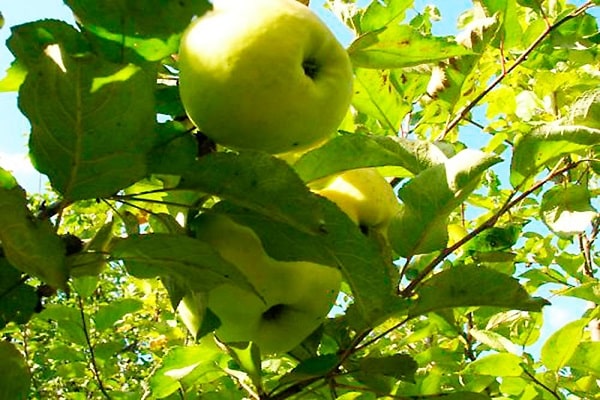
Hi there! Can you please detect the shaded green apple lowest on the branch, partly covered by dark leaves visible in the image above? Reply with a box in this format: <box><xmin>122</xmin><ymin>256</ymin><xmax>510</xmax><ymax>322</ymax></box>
<box><xmin>194</xmin><ymin>213</ymin><xmax>342</xmax><ymax>354</ymax></box>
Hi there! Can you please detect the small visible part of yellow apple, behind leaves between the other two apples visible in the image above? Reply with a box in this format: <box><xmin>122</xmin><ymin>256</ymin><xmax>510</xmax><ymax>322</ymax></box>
<box><xmin>309</xmin><ymin>168</ymin><xmax>400</xmax><ymax>233</ymax></box>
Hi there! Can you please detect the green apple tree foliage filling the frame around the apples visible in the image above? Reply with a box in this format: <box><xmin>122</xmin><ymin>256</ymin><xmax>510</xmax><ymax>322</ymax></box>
<box><xmin>0</xmin><ymin>0</ymin><xmax>600</xmax><ymax>399</ymax></box>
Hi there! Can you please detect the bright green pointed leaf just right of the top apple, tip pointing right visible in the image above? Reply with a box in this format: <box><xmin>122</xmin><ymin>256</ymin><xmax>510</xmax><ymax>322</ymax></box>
<box><xmin>348</xmin><ymin>25</ymin><xmax>473</xmax><ymax>69</ymax></box>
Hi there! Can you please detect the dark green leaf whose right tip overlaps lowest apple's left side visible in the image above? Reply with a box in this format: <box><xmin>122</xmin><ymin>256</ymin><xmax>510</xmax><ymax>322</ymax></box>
<box><xmin>110</xmin><ymin>233</ymin><xmax>253</xmax><ymax>292</ymax></box>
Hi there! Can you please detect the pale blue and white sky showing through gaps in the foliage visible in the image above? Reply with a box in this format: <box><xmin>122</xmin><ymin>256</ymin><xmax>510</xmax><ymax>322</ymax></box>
<box><xmin>0</xmin><ymin>0</ymin><xmax>584</xmax><ymax>354</ymax></box>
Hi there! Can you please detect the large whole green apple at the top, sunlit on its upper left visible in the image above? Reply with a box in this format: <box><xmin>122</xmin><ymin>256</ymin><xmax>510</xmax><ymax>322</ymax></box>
<box><xmin>179</xmin><ymin>0</ymin><xmax>353</xmax><ymax>154</ymax></box>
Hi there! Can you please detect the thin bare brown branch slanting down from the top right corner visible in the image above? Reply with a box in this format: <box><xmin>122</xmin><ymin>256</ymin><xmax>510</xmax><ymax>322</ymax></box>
<box><xmin>437</xmin><ymin>0</ymin><xmax>594</xmax><ymax>140</ymax></box>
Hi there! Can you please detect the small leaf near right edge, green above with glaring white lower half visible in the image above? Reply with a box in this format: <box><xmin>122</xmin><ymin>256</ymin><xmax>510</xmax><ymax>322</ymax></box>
<box><xmin>540</xmin><ymin>185</ymin><xmax>598</xmax><ymax>238</ymax></box>
